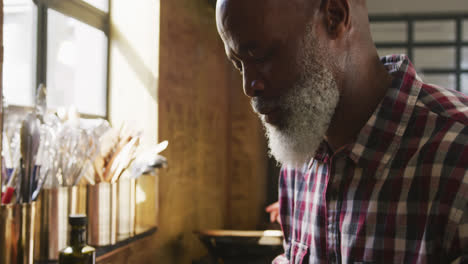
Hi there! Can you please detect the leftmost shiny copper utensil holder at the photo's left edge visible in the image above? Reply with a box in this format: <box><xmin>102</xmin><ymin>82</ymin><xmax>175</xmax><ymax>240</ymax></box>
<box><xmin>0</xmin><ymin>202</ymin><xmax>36</xmax><ymax>264</ymax></box>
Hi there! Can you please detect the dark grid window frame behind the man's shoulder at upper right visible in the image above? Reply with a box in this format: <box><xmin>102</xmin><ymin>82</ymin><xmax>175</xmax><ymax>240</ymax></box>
<box><xmin>369</xmin><ymin>13</ymin><xmax>468</xmax><ymax>91</ymax></box>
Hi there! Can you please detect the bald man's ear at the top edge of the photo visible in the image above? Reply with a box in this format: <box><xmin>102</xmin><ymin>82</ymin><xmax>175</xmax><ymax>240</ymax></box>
<box><xmin>321</xmin><ymin>0</ymin><xmax>351</xmax><ymax>38</ymax></box>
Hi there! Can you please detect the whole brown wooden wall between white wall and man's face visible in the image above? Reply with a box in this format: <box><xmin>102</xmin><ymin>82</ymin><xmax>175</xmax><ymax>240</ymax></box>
<box><xmin>155</xmin><ymin>0</ymin><xmax>267</xmax><ymax>264</ymax></box>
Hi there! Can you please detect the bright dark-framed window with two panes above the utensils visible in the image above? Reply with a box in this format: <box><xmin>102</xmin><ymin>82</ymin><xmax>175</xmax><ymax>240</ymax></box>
<box><xmin>3</xmin><ymin>0</ymin><xmax>109</xmax><ymax>117</ymax></box>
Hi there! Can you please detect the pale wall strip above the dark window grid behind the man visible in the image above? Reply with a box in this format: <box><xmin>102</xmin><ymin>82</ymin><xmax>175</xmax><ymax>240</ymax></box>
<box><xmin>367</xmin><ymin>0</ymin><xmax>468</xmax><ymax>15</ymax></box>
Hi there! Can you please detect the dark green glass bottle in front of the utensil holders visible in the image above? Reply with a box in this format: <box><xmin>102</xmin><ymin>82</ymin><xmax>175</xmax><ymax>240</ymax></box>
<box><xmin>59</xmin><ymin>215</ymin><xmax>96</xmax><ymax>264</ymax></box>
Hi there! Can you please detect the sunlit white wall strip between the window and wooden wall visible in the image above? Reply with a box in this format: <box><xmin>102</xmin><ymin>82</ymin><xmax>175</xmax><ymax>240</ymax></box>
<box><xmin>109</xmin><ymin>0</ymin><xmax>159</xmax><ymax>145</ymax></box>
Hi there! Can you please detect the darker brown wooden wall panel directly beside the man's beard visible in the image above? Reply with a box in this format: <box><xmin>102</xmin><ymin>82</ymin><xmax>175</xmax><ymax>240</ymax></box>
<box><xmin>228</xmin><ymin>72</ymin><xmax>266</xmax><ymax>229</ymax></box>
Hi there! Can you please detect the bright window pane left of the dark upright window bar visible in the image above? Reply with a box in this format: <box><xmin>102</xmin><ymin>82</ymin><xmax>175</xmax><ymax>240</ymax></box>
<box><xmin>3</xmin><ymin>0</ymin><xmax>37</xmax><ymax>106</ymax></box>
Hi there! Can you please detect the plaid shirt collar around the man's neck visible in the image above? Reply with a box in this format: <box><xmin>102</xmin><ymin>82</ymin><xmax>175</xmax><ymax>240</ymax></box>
<box><xmin>314</xmin><ymin>55</ymin><xmax>422</xmax><ymax>174</ymax></box>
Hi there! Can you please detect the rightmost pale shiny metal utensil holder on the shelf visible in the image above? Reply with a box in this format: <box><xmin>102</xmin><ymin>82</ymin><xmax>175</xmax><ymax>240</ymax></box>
<box><xmin>117</xmin><ymin>178</ymin><xmax>136</xmax><ymax>241</ymax></box>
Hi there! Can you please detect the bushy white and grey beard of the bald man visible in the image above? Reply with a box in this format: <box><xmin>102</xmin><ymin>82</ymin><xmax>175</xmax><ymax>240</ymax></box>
<box><xmin>252</xmin><ymin>27</ymin><xmax>340</xmax><ymax>167</ymax></box>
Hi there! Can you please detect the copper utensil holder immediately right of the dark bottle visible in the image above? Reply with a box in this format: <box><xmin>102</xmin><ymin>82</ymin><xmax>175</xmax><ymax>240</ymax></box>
<box><xmin>87</xmin><ymin>182</ymin><xmax>117</xmax><ymax>246</ymax></box>
